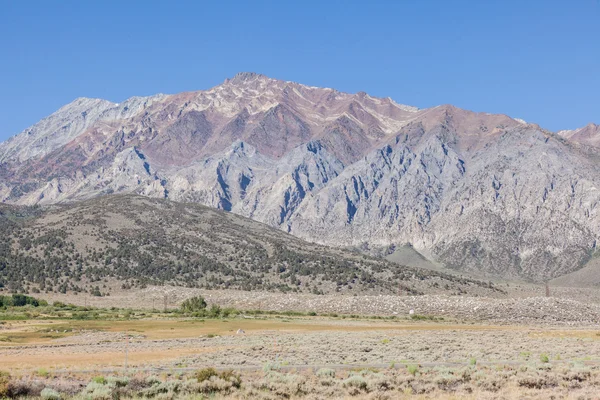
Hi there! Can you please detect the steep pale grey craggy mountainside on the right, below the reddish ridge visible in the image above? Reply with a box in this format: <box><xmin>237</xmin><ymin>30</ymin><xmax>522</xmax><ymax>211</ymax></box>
<box><xmin>289</xmin><ymin>115</ymin><xmax>600</xmax><ymax>280</ymax></box>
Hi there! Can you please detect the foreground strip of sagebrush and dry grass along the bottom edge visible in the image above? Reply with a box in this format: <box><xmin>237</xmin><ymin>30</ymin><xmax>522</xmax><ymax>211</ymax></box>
<box><xmin>4</xmin><ymin>364</ymin><xmax>600</xmax><ymax>400</ymax></box>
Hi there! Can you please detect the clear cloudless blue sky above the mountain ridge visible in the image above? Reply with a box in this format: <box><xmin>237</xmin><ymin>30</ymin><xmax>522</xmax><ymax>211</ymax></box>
<box><xmin>0</xmin><ymin>0</ymin><xmax>600</xmax><ymax>140</ymax></box>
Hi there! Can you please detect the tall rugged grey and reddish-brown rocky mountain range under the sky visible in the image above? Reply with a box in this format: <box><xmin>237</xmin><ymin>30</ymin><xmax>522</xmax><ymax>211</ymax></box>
<box><xmin>0</xmin><ymin>73</ymin><xmax>600</xmax><ymax>281</ymax></box>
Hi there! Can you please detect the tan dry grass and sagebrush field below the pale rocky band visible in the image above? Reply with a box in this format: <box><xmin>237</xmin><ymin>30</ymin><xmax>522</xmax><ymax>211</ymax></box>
<box><xmin>0</xmin><ymin>310</ymin><xmax>600</xmax><ymax>399</ymax></box>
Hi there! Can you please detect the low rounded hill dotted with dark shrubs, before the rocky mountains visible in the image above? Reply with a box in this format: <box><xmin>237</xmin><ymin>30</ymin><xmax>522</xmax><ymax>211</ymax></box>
<box><xmin>0</xmin><ymin>194</ymin><xmax>504</xmax><ymax>296</ymax></box>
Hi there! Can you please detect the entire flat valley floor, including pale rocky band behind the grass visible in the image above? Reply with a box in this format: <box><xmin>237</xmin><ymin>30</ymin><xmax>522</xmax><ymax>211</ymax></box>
<box><xmin>0</xmin><ymin>287</ymin><xmax>600</xmax><ymax>399</ymax></box>
